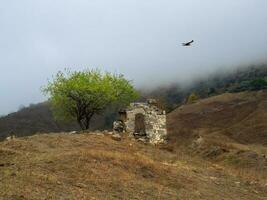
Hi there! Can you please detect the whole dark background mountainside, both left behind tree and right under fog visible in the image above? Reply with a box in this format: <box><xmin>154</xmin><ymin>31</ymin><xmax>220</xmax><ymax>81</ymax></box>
<box><xmin>0</xmin><ymin>65</ymin><xmax>267</xmax><ymax>139</ymax></box>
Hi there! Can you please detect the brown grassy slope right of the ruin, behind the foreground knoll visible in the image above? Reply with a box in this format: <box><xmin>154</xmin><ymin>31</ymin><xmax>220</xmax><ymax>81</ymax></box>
<box><xmin>167</xmin><ymin>90</ymin><xmax>267</xmax><ymax>179</ymax></box>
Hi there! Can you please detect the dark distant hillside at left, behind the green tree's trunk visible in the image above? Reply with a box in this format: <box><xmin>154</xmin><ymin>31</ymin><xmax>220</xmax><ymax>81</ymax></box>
<box><xmin>0</xmin><ymin>102</ymin><xmax>115</xmax><ymax>141</ymax></box>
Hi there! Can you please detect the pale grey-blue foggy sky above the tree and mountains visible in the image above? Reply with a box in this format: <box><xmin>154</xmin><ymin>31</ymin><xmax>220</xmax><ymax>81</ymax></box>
<box><xmin>0</xmin><ymin>0</ymin><xmax>267</xmax><ymax>114</ymax></box>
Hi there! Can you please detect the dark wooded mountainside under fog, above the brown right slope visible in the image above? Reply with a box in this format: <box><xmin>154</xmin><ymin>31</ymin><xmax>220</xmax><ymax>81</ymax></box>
<box><xmin>148</xmin><ymin>64</ymin><xmax>267</xmax><ymax>112</ymax></box>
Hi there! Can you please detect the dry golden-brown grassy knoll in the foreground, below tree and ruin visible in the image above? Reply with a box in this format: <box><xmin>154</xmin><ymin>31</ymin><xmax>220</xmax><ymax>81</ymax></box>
<box><xmin>0</xmin><ymin>133</ymin><xmax>267</xmax><ymax>200</ymax></box>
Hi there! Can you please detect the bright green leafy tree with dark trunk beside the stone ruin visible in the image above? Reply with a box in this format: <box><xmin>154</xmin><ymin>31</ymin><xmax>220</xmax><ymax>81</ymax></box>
<box><xmin>43</xmin><ymin>70</ymin><xmax>139</xmax><ymax>130</ymax></box>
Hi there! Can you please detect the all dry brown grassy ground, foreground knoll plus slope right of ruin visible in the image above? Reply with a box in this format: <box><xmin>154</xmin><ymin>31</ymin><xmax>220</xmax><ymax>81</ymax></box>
<box><xmin>0</xmin><ymin>90</ymin><xmax>267</xmax><ymax>200</ymax></box>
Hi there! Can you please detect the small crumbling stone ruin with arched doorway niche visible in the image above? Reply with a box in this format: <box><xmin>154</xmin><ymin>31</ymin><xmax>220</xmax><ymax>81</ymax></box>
<box><xmin>113</xmin><ymin>99</ymin><xmax>167</xmax><ymax>144</ymax></box>
